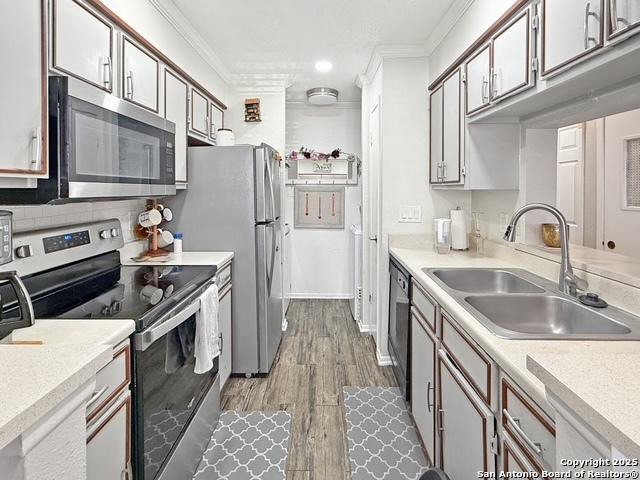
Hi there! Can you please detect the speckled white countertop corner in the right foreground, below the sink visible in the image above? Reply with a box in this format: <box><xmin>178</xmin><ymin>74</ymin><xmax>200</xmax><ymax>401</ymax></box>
<box><xmin>527</xmin><ymin>352</ymin><xmax>640</xmax><ymax>459</ymax></box>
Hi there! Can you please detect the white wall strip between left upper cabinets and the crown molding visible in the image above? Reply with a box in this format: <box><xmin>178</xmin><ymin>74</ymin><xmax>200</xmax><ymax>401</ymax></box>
<box><xmin>102</xmin><ymin>0</ymin><xmax>228</xmax><ymax>103</ymax></box>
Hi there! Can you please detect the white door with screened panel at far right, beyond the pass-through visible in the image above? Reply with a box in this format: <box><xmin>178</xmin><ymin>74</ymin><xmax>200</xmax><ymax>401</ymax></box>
<box><xmin>603</xmin><ymin>110</ymin><xmax>640</xmax><ymax>256</ymax></box>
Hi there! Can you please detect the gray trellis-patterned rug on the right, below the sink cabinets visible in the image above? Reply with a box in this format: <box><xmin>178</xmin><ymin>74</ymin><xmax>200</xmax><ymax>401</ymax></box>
<box><xmin>343</xmin><ymin>387</ymin><xmax>428</xmax><ymax>480</ymax></box>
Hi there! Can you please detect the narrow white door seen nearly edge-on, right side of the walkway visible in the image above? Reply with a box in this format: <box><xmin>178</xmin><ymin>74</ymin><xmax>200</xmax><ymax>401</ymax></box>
<box><xmin>368</xmin><ymin>98</ymin><xmax>380</xmax><ymax>334</ymax></box>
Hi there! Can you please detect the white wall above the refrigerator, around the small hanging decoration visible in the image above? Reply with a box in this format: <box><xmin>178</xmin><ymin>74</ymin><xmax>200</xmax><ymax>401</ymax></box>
<box><xmin>224</xmin><ymin>87</ymin><xmax>286</xmax><ymax>154</ymax></box>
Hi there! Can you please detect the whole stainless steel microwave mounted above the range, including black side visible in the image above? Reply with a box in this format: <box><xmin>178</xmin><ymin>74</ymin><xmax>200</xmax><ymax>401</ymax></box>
<box><xmin>2</xmin><ymin>77</ymin><xmax>176</xmax><ymax>204</ymax></box>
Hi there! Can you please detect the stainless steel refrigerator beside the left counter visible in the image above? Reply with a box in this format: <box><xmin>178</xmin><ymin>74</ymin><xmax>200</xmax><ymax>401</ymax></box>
<box><xmin>168</xmin><ymin>144</ymin><xmax>283</xmax><ymax>375</ymax></box>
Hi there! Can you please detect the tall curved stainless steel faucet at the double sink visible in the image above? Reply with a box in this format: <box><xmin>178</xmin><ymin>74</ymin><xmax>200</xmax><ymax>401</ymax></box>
<box><xmin>504</xmin><ymin>203</ymin><xmax>589</xmax><ymax>297</ymax></box>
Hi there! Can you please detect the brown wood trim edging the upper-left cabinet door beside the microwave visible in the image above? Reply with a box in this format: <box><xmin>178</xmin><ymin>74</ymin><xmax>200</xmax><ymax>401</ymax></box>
<box><xmin>0</xmin><ymin>0</ymin><xmax>49</xmax><ymax>178</ymax></box>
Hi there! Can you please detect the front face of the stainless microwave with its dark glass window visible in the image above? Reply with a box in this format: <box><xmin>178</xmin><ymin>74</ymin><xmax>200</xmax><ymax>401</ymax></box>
<box><xmin>60</xmin><ymin>80</ymin><xmax>175</xmax><ymax>199</ymax></box>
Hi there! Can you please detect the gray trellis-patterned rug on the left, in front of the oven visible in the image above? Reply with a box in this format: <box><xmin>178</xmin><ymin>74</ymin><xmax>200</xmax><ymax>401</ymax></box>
<box><xmin>193</xmin><ymin>412</ymin><xmax>291</xmax><ymax>480</ymax></box>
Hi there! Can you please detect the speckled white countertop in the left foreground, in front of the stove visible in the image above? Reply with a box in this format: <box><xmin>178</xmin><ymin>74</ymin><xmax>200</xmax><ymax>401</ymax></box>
<box><xmin>0</xmin><ymin>320</ymin><xmax>135</xmax><ymax>449</ymax></box>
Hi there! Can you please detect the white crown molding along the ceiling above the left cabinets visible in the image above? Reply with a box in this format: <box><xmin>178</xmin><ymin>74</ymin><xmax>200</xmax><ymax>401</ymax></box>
<box><xmin>149</xmin><ymin>0</ymin><xmax>233</xmax><ymax>83</ymax></box>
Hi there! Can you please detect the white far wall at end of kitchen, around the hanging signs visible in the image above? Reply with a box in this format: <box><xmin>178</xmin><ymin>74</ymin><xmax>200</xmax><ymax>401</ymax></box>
<box><xmin>285</xmin><ymin>103</ymin><xmax>362</xmax><ymax>298</ymax></box>
